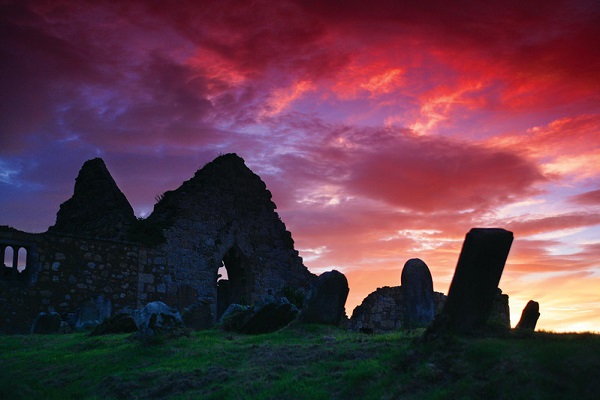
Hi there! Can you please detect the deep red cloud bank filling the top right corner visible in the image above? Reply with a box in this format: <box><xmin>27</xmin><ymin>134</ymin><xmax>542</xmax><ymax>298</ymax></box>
<box><xmin>298</xmin><ymin>0</ymin><xmax>600</xmax><ymax>88</ymax></box>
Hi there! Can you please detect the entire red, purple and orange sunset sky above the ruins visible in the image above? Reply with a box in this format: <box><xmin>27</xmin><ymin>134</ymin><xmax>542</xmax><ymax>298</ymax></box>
<box><xmin>0</xmin><ymin>0</ymin><xmax>600</xmax><ymax>332</ymax></box>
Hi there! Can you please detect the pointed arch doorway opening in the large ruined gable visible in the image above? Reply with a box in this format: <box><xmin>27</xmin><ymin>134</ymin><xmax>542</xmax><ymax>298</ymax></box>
<box><xmin>217</xmin><ymin>244</ymin><xmax>254</xmax><ymax>320</ymax></box>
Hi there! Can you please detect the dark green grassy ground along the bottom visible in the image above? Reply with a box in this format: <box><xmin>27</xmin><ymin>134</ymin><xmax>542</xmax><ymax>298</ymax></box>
<box><xmin>0</xmin><ymin>325</ymin><xmax>600</xmax><ymax>399</ymax></box>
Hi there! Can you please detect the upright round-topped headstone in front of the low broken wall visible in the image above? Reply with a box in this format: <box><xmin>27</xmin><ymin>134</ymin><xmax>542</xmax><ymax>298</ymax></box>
<box><xmin>401</xmin><ymin>258</ymin><xmax>434</xmax><ymax>328</ymax></box>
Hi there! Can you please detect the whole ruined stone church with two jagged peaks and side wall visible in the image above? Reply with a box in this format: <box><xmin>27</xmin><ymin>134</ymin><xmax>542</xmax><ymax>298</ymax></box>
<box><xmin>0</xmin><ymin>154</ymin><xmax>316</xmax><ymax>332</ymax></box>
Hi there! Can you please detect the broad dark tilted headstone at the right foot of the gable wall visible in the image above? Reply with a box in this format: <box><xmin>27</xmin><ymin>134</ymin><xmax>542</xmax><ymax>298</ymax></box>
<box><xmin>300</xmin><ymin>270</ymin><xmax>350</xmax><ymax>325</ymax></box>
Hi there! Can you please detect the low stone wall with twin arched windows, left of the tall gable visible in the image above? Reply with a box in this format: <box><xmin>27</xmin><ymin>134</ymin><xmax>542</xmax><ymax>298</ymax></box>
<box><xmin>0</xmin><ymin>227</ymin><xmax>176</xmax><ymax>333</ymax></box>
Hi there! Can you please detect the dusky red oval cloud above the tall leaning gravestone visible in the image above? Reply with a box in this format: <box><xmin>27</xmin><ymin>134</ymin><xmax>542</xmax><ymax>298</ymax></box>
<box><xmin>348</xmin><ymin>133</ymin><xmax>544</xmax><ymax>212</ymax></box>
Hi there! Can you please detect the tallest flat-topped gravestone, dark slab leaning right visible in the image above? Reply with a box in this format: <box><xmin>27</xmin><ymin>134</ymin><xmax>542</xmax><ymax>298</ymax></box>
<box><xmin>428</xmin><ymin>228</ymin><xmax>513</xmax><ymax>334</ymax></box>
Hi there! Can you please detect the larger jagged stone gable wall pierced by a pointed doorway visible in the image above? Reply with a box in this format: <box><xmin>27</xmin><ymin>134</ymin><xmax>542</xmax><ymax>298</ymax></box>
<box><xmin>147</xmin><ymin>154</ymin><xmax>314</xmax><ymax>315</ymax></box>
